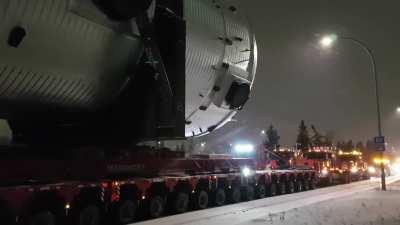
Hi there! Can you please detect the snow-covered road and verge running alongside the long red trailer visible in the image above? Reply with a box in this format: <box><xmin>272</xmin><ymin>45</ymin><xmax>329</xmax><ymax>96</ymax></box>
<box><xmin>135</xmin><ymin>176</ymin><xmax>400</xmax><ymax>225</ymax></box>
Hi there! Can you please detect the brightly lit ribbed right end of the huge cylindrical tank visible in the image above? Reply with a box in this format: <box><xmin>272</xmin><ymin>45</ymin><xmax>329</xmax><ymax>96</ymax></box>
<box><xmin>184</xmin><ymin>0</ymin><xmax>257</xmax><ymax>136</ymax></box>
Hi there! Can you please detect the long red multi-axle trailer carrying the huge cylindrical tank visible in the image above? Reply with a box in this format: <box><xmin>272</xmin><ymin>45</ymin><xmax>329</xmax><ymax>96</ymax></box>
<box><xmin>0</xmin><ymin>150</ymin><xmax>318</xmax><ymax>225</ymax></box>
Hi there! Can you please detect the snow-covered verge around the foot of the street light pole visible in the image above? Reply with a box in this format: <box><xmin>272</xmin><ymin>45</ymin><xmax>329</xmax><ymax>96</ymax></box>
<box><xmin>245</xmin><ymin>182</ymin><xmax>400</xmax><ymax>225</ymax></box>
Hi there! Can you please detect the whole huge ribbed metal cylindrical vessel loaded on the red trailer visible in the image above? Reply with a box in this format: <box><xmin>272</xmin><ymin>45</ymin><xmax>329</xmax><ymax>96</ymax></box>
<box><xmin>0</xmin><ymin>0</ymin><xmax>257</xmax><ymax>144</ymax></box>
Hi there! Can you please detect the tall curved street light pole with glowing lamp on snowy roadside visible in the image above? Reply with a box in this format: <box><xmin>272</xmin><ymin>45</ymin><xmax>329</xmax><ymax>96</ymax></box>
<box><xmin>321</xmin><ymin>36</ymin><xmax>386</xmax><ymax>191</ymax></box>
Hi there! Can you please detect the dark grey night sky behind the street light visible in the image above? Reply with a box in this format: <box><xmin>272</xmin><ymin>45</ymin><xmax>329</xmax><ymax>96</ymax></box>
<box><xmin>206</xmin><ymin>0</ymin><xmax>400</xmax><ymax>149</ymax></box>
